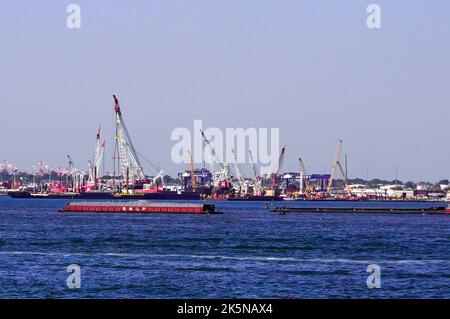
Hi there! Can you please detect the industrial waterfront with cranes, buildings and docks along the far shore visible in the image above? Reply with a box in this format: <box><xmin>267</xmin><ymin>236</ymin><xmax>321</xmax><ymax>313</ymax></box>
<box><xmin>0</xmin><ymin>95</ymin><xmax>450</xmax><ymax>212</ymax></box>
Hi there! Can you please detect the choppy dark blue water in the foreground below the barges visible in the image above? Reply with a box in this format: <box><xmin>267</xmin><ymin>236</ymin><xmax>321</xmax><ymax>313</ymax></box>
<box><xmin>0</xmin><ymin>197</ymin><xmax>450</xmax><ymax>298</ymax></box>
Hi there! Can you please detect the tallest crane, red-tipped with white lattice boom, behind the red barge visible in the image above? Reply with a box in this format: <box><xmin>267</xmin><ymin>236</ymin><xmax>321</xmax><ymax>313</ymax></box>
<box><xmin>113</xmin><ymin>95</ymin><xmax>145</xmax><ymax>187</ymax></box>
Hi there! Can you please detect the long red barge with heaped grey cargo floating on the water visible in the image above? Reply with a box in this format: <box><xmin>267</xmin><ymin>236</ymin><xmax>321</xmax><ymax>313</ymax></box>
<box><xmin>59</xmin><ymin>200</ymin><xmax>222</xmax><ymax>214</ymax></box>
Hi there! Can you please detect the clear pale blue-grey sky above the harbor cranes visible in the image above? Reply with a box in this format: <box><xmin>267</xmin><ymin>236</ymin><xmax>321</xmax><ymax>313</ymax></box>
<box><xmin>0</xmin><ymin>0</ymin><xmax>450</xmax><ymax>181</ymax></box>
